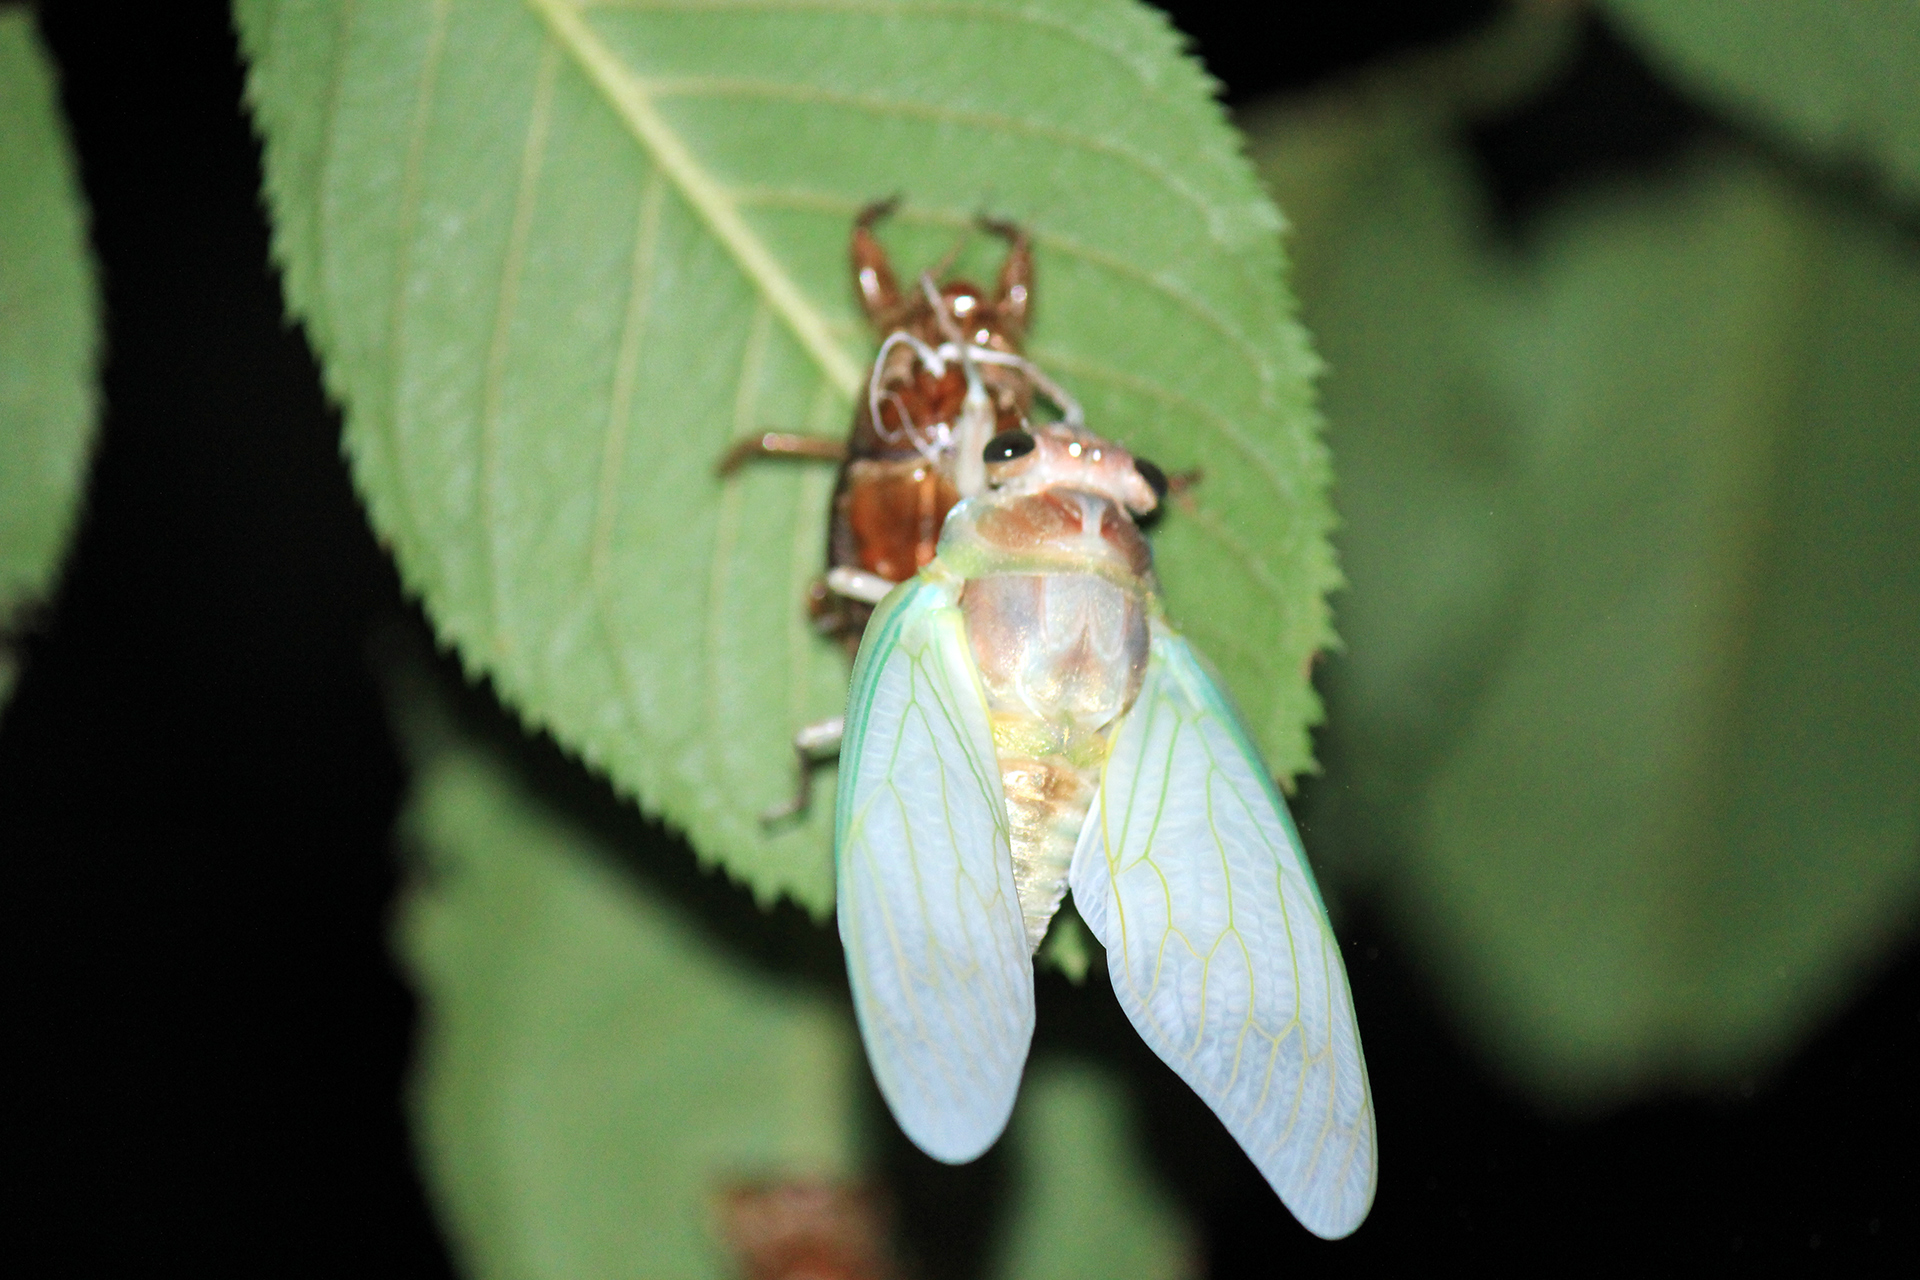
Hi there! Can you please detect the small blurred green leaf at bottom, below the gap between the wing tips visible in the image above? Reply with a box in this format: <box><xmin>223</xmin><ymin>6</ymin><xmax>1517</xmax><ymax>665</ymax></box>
<box><xmin>993</xmin><ymin>1059</ymin><xmax>1200</xmax><ymax>1280</ymax></box>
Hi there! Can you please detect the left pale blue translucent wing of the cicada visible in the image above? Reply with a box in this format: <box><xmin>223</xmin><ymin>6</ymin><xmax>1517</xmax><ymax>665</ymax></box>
<box><xmin>833</xmin><ymin>580</ymin><xmax>1033</xmax><ymax>1163</ymax></box>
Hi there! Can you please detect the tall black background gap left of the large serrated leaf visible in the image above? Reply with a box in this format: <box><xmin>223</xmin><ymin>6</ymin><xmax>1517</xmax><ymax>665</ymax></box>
<box><xmin>0</xmin><ymin>2</ymin><xmax>451</xmax><ymax>1276</ymax></box>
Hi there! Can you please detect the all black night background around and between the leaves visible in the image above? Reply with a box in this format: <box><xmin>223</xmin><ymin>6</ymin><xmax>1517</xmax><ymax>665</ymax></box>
<box><xmin>0</xmin><ymin>2</ymin><xmax>1920</xmax><ymax>1278</ymax></box>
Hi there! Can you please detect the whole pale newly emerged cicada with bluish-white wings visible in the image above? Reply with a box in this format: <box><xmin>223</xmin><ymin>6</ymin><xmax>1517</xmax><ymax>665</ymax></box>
<box><xmin>835</xmin><ymin>422</ymin><xmax>1377</xmax><ymax>1238</ymax></box>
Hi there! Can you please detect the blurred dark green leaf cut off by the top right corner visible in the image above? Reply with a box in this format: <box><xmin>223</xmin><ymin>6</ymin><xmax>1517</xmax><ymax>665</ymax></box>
<box><xmin>1605</xmin><ymin>0</ymin><xmax>1920</xmax><ymax>200</ymax></box>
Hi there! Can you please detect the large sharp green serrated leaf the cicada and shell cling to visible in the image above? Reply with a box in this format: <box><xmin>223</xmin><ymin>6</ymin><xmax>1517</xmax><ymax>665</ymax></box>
<box><xmin>238</xmin><ymin>0</ymin><xmax>1334</xmax><ymax>912</ymax></box>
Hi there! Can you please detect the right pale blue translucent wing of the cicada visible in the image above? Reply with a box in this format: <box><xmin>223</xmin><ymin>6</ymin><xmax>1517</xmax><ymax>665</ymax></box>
<box><xmin>1069</xmin><ymin>628</ymin><xmax>1377</xmax><ymax>1240</ymax></box>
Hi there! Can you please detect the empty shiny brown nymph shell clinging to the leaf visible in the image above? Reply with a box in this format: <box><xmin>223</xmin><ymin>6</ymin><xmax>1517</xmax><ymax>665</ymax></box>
<box><xmin>720</xmin><ymin>200</ymin><xmax>1081</xmax><ymax>819</ymax></box>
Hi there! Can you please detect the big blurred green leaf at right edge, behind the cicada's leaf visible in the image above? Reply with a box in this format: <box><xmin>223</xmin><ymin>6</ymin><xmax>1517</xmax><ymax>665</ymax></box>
<box><xmin>1407</xmin><ymin>157</ymin><xmax>1920</xmax><ymax>1100</ymax></box>
